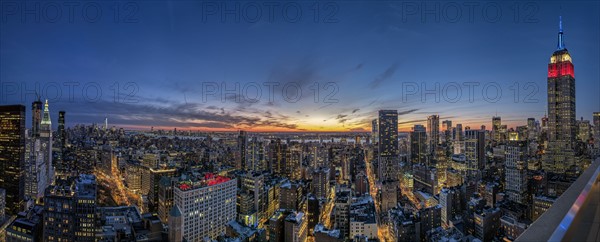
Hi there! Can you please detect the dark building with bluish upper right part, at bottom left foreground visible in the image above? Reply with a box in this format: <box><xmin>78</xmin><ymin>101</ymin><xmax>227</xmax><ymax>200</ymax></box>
<box><xmin>43</xmin><ymin>174</ymin><xmax>96</xmax><ymax>241</ymax></box>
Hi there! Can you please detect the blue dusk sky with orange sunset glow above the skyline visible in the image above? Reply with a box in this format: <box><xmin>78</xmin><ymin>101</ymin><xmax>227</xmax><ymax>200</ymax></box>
<box><xmin>0</xmin><ymin>1</ymin><xmax>600</xmax><ymax>131</ymax></box>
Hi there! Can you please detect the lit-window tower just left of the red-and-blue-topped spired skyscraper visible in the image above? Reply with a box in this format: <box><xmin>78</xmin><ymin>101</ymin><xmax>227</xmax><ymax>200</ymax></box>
<box><xmin>504</xmin><ymin>141</ymin><xmax>528</xmax><ymax>204</ymax></box>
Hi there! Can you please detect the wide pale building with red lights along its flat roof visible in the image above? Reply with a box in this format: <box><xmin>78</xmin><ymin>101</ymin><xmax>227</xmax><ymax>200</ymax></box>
<box><xmin>169</xmin><ymin>173</ymin><xmax>237</xmax><ymax>241</ymax></box>
